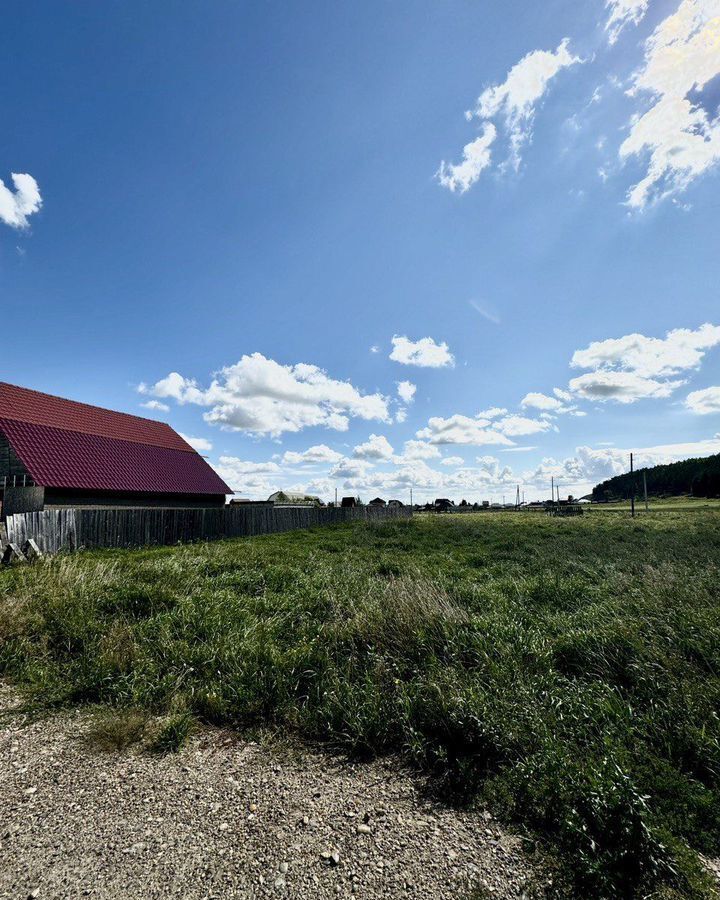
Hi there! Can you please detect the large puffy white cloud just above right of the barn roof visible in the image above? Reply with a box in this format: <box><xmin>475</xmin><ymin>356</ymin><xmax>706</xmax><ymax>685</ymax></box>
<box><xmin>138</xmin><ymin>353</ymin><xmax>390</xmax><ymax>437</ymax></box>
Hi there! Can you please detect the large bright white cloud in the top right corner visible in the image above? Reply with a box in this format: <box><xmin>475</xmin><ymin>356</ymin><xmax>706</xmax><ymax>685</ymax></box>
<box><xmin>620</xmin><ymin>0</ymin><xmax>720</xmax><ymax>209</ymax></box>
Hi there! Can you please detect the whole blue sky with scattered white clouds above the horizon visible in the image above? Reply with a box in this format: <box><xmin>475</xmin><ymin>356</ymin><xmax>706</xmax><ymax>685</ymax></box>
<box><xmin>0</xmin><ymin>0</ymin><xmax>720</xmax><ymax>500</ymax></box>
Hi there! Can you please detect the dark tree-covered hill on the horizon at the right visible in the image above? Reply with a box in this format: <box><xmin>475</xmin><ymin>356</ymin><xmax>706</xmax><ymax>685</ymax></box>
<box><xmin>592</xmin><ymin>453</ymin><xmax>720</xmax><ymax>501</ymax></box>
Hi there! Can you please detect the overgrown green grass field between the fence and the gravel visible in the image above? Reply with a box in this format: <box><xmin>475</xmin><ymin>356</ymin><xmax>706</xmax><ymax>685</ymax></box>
<box><xmin>0</xmin><ymin>508</ymin><xmax>720</xmax><ymax>897</ymax></box>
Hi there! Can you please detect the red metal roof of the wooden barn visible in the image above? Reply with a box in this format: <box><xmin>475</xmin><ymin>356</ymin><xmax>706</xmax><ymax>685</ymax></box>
<box><xmin>0</xmin><ymin>382</ymin><xmax>232</xmax><ymax>494</ymax></box>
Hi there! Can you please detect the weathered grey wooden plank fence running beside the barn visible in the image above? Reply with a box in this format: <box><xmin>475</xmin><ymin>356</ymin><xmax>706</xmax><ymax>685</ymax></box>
<box><xmin>6</xmin><ymin>506</ymin><xmax>412</xmax><ymax>553</ymax></box>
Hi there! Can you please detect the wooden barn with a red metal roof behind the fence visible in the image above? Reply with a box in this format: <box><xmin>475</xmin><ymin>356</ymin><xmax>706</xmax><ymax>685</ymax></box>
<box><xmin>0</xmin><ymin>382</ymin><xmax>232</xmax><ymax>513</ymax></box>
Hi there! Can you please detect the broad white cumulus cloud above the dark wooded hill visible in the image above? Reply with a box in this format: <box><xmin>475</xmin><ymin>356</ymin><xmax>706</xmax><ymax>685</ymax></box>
<box><xmin>569</xmin><ymin>323</ymin><xmax>720</xmax><ymax>403</ymax></box>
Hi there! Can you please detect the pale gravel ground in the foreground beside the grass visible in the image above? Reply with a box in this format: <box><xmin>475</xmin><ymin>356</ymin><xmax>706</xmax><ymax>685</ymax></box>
<box><xmin>0</xmin><ymin>686</ymin><xmax>535</xmax><ymax>900</ymax></box>
